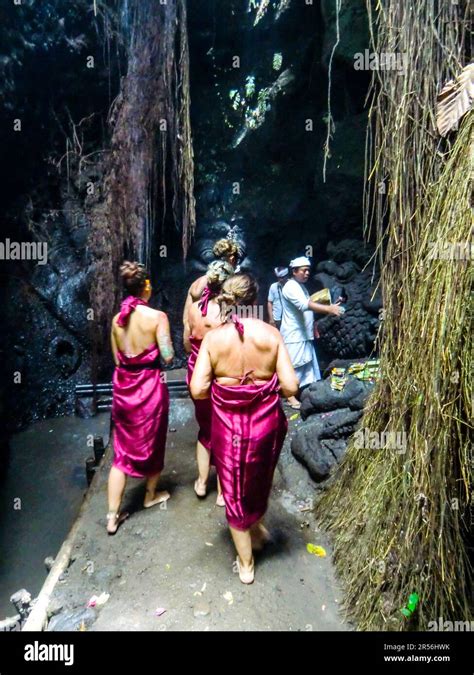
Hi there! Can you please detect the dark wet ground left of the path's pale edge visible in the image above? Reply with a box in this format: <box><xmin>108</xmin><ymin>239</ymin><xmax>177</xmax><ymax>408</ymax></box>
<box><xmin>0</xmin><ymin>414</ymin><xmax>110</xmax><ymax>620</ymax></box>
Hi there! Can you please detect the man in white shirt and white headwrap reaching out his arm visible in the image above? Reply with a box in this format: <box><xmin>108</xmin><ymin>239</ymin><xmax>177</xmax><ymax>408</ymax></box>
<box><xmin>280</xmin><ymin>256</ymin><xmax>343</xmax><ymax>409</ymax></box>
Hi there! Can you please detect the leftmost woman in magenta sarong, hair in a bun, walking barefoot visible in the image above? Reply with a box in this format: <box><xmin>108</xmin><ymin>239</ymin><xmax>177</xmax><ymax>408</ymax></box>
<box><xmin>107</xmin><ymin>261</ymin><xmax>174</xmax><ymax>534</ymax></box>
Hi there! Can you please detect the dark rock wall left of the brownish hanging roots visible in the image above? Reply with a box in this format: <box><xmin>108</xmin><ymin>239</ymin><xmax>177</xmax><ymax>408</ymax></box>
<box><xmin>0</xmin><ymin>0</ymin><xmax>123</xmax><ymax>429</ymax></box>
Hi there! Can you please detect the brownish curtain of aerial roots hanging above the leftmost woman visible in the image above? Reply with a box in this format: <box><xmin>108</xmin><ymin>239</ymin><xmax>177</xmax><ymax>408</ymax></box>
<box><xmin>88</xmin><ymin>0</ymin><xmax>195</xmax><ymax>364</ymax></box>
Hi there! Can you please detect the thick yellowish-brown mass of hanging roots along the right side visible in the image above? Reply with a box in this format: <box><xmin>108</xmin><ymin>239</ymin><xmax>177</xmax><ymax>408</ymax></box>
<box><xmin>317</xmin><ymin>0</ymin><xmax>474</xmax><ymax>630</ymax></box>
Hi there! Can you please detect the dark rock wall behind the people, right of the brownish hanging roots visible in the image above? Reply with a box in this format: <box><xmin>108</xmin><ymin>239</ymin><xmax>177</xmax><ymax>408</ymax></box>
<box><xmin>160</xmin><ymin>0</ymin><xmax>378</xmax><ymax>362</ymax></box>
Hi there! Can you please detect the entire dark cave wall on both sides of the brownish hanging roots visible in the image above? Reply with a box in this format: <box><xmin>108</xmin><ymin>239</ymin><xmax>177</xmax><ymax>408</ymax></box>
<box><xmin>0</xmin><ymin>0</ymin><xmax>378</xmax><ymax>425</ymax></box>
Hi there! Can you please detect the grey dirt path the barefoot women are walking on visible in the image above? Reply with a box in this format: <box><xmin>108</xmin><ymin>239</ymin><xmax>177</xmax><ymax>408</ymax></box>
<box><xmin>50</xmin><ymin>400</ymin><xmax>351</xmax><ymax>631</ymax></box>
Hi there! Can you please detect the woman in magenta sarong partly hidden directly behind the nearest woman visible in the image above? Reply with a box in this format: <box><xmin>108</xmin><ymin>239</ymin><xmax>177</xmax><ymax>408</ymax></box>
<box><xmin>183</xmin><ymin>260</ymin><xmax>234</xmax><ymax>506</ymax></box>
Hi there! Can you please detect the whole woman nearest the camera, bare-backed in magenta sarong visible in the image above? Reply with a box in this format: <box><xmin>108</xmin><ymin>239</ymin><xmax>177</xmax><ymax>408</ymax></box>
<box><xmin>191</xmin><ymin>274</ymin><xmax>298</xmax><ymax>584</ymax></box>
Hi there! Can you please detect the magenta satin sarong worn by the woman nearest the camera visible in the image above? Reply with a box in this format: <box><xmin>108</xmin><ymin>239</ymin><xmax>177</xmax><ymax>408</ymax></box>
<box><xmin>211</xmin><ymin>373</ymin><xmax>288</xmax><ymax>530</ymax></box>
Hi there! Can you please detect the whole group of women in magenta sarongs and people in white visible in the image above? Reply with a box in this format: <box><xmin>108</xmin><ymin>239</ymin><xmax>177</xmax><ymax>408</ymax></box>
<box><xmin>107</xmin><ymin>239</ymin><xmax>339</xmax><ymax>584</ymax></box>
